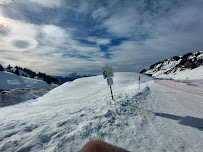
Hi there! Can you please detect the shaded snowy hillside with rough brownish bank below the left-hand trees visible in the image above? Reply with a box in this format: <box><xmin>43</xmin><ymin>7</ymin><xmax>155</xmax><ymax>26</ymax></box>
<box><xmin>0</xmin><ymin>71</ymin><xmax>54</xmax><ymax>107</ymax></box>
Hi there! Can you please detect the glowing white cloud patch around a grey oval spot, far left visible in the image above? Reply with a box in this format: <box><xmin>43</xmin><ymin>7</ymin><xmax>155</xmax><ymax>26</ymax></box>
<box><xmin>0</xmin><ymin>17</ymin><xmax>38</xmax><ymax>51</ymax></box>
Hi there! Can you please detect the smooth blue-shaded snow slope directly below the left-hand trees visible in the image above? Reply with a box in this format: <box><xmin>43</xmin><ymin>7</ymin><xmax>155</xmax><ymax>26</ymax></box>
<box><xmin>0</xmin><ymin>71</ymin><xmax>51</xmax><ymax>90</ymax></box>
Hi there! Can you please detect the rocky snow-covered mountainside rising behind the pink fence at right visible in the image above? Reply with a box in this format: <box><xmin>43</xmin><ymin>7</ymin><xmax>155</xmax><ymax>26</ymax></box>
<box><xmin>141</xmin><ymin>51</ymin><xmax>203</xmax><ymax>79</ymax></box>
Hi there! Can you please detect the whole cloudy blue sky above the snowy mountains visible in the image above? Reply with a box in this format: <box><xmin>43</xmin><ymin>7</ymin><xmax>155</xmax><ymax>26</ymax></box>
<box><xmin>0</xmin><ymin>0</ymin><xmax>203</xmax><ymax>75</ymax></box>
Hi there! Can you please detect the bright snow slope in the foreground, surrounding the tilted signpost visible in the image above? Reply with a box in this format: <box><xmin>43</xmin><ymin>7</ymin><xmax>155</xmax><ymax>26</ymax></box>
<box><xmin>0</xmin><ymin>73</ymin><xmax>203</xmax><ymax>152</ymax></box>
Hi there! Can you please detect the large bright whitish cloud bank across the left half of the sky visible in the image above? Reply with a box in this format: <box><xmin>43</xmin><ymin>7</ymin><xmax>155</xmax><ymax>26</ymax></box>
<box><xmin>0</xmin><ymin>17</ymin><xmax>104</xmax><ymax>74</ymax></box>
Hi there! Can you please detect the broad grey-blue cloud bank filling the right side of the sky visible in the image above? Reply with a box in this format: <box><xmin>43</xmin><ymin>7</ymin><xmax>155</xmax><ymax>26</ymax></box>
<box><xmin>97</xmin><ymin>1</ymin><xmax>203</xmax><ymax>65</ymax></box>
